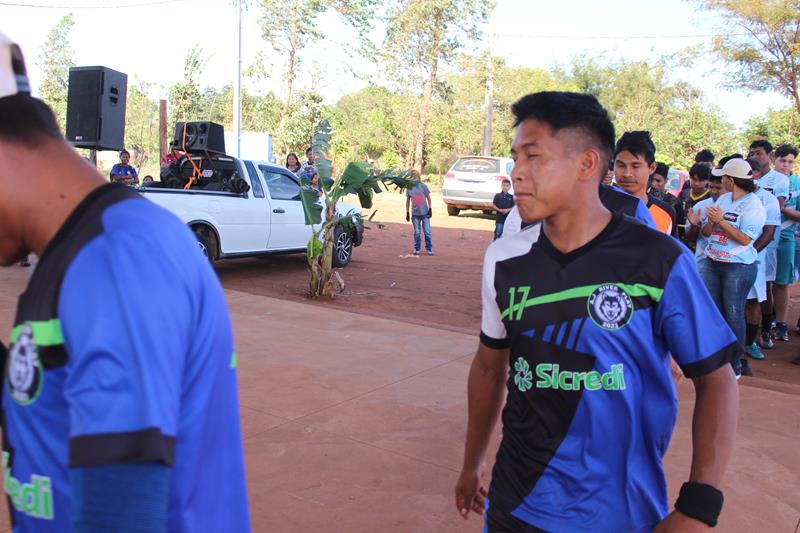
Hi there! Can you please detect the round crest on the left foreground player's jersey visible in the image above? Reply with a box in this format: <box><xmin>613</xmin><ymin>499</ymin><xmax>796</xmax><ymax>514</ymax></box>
<box><xmin>6</xmin><ymin>324</ymin><xmax>44</xmax><ymax>405</ymax></box>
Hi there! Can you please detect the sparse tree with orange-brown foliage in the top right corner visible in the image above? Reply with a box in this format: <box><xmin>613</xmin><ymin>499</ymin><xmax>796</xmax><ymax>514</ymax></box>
<box><xmin>699</xmin><ymin>0</ymin><xmax>800</xmax><ymax>112</ymax></box>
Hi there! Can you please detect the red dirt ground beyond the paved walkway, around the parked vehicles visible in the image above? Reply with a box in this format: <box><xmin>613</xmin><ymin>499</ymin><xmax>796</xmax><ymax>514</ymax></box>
<box><xmin>217</xmin><ymin>193</ymin><xmax>800</xmax><ymax>394</ymax></box>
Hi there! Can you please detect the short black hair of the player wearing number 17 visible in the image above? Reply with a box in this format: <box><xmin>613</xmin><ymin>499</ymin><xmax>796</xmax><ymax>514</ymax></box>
<box><xmin>511</xmin><ymin>91</ymin><xmax>614</xmax><ymax>167</ymax></box>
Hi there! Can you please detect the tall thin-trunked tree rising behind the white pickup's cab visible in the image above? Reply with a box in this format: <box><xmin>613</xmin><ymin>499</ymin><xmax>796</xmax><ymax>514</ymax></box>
<box><xmin>259</xmin><ymin>0</ymin><xmax>377</xmax><ymax>154</ymax></box>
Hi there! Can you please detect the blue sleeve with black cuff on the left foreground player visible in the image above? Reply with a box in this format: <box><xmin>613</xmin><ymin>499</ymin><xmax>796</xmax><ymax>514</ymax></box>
<box><xmin>58</xmin><ymin>229</ymin><xmax>189</xmax><ymax>466</ymax></box>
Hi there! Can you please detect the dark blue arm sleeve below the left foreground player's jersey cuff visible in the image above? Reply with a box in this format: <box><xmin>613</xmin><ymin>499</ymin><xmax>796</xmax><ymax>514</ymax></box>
<box><xmin>69</xmin><ymin>462</ymin><xmax>171</xmax><ymax>533</ymax></box>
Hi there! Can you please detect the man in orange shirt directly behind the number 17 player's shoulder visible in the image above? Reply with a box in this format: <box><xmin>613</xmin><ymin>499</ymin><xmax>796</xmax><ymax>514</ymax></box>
<box><xmin>614</xmin><ymin>131</ymin><xmax>678</xmax><ymax>237</ymax></box>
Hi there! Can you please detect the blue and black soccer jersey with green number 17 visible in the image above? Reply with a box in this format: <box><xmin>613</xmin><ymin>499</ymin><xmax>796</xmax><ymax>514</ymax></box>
<box><xmin>481</xmin><ymin>214</ymin><xmax>741</xmax><ymax>532</ymax></box>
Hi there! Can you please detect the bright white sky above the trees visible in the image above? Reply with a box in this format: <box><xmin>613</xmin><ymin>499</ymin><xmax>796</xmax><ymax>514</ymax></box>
<box><xmin>0</xmin><ymin>0</ymin><xmax>789</xmax><ymax>126</ymax></box>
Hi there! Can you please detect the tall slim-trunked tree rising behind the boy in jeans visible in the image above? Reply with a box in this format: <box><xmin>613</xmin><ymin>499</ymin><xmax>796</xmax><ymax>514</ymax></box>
<box><xmin>384</xmin><ymin>0</ymin><xmax>492</xmax><ymax>172</ymax></box>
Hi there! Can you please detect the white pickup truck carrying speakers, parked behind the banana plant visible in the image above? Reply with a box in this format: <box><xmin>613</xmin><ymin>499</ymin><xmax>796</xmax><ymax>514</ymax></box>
<box><xmin>139</xmin><ymin>156</ymin><xmax>363</xmax><ymax>267</ymax></box>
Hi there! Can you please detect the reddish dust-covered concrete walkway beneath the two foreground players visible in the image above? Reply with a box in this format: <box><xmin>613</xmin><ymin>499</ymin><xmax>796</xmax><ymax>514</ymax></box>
<box><xmin>0</xmin><ymin>269</ymin><xmax>800</xmax><ymax>533</ymax></box>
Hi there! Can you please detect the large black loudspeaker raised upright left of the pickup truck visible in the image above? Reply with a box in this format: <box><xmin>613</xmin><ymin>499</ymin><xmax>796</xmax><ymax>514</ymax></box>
<box><xmin>67</xmin><ymin>67</ymin><xmax>128</xmax><ymax>150</ymax></box>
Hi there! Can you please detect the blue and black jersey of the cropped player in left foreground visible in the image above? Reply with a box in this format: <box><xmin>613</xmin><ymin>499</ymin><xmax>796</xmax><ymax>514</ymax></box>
<box><xmin>2</xmin><ymin>185</ymin><xmax>249</xmax><ymax>533</ymax></box>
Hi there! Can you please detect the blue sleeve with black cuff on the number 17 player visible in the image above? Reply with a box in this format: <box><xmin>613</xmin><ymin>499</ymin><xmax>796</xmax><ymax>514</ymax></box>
<box><xmin>655</xmin><ymin>250</ymin><xmax>742</xmax><ymax>378</ymax></box>
